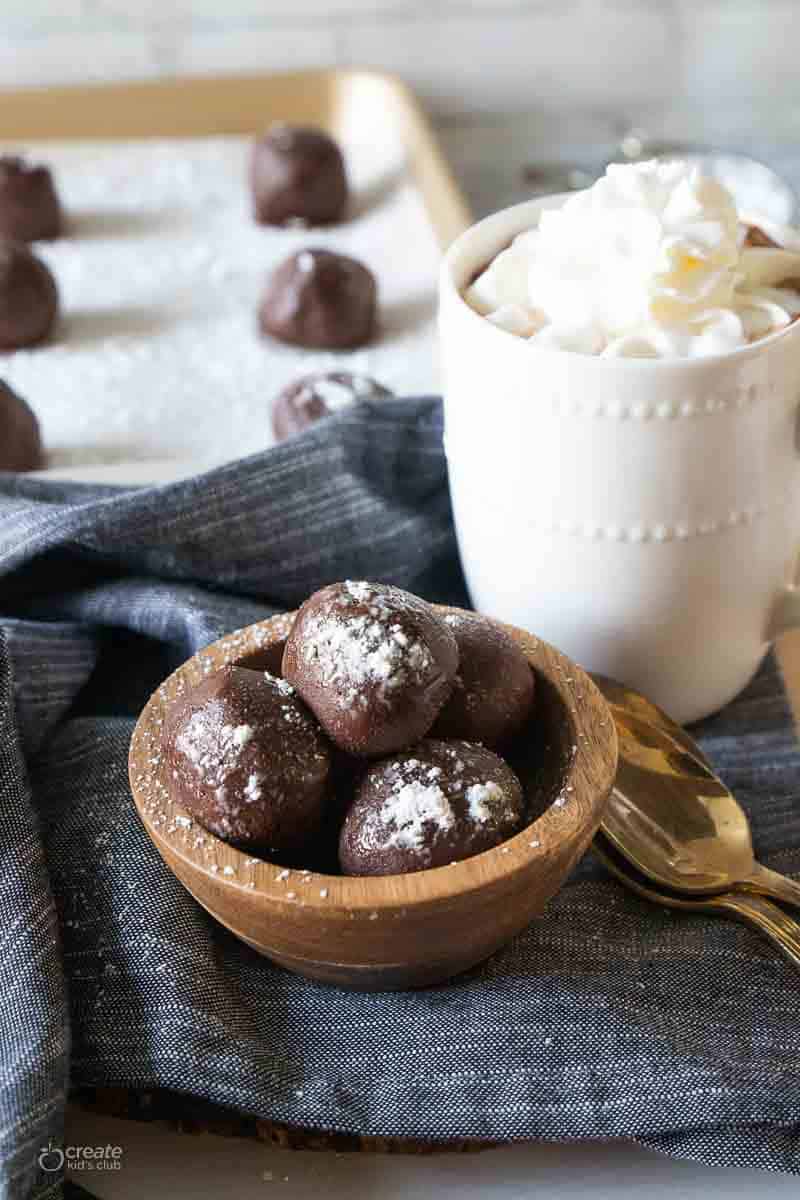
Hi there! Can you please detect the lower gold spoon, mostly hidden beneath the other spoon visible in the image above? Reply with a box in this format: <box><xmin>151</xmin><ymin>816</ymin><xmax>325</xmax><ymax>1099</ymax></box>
<box><xmin>591</xmin><ymin>833</ymin><xmax>800</xmax><ymax>967</ymax></box>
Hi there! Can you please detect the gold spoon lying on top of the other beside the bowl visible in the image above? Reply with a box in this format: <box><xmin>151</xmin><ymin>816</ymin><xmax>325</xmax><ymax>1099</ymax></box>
<box><xmin>595</xmin><ymin>676</ymin><xmax>800</xmax><ymax>906</ymax></box>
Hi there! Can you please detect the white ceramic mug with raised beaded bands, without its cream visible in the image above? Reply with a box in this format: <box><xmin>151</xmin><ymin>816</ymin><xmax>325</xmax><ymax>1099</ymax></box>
<box><xmin>439</xmin><ymin>196</ymin><xmax>800</xmax><ymax>722</ymax></box>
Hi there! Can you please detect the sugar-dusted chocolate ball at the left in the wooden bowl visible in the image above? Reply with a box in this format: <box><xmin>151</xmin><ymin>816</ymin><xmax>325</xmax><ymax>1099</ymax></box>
<box><xmin>162</xmin><ymin>666</ymin><xmax>330</xmax><ymax>858</ymax></box>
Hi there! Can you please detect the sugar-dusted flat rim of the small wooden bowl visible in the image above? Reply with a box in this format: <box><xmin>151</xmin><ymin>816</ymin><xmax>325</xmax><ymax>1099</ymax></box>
<box><xmin>128</xmin><ymin>606</ymin><xmax>616</xmax><ymax>919</ymax></box>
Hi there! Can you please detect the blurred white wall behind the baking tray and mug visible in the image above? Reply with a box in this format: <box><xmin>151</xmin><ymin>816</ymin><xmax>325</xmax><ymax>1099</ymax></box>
<box><xmin>0</xmin><ymin>0</ymin><xmax>800</xmax><ymax>128</ymax></box>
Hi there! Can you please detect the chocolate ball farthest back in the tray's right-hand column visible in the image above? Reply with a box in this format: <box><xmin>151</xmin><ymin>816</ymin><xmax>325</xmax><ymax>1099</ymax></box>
<box><xmin>249</xmin><ymin>125</ymin><xmax>348</xmax><ymax>224</ymax></box>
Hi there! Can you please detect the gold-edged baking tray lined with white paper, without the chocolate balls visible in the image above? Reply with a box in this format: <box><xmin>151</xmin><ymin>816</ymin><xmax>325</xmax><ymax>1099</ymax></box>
<box><xmin>0</xmin><ymin>70</ymin><xmax>469</xmax><ymax>484</ymax></box>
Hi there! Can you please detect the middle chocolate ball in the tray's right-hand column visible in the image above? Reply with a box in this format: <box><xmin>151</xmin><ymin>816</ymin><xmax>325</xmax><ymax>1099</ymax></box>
<box><xmin>259</xmin><ymin>250</ymin><xmax>377</xmax><ymax>350</ymax></box>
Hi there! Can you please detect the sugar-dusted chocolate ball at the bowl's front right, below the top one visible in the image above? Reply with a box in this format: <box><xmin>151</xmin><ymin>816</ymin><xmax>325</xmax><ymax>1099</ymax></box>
<box><xmin>339</xmin><ymin>738</ymin><xmax>524</xmax><ymax>875</ymax></box>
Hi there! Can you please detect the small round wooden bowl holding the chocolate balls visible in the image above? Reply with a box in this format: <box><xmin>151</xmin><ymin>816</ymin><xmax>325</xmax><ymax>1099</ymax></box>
<box><xmin>130</xmin><ymin>614</ymin><xmax>616</xmax><ymax>991</ymax></box>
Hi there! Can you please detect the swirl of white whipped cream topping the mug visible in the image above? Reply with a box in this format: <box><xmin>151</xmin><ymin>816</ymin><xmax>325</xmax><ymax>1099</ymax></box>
<box><xmin>465</xmin><ymin>161</ymin><xmax>800</xmax><ymax>358</ymax></box>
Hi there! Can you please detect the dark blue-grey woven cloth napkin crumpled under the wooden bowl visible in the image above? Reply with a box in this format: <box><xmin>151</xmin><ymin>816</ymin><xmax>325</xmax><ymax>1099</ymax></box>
<box><xmin>0</xmin><ymin>398</ymin><xmax>800</xmax><ymax>1196</ymax></box>
